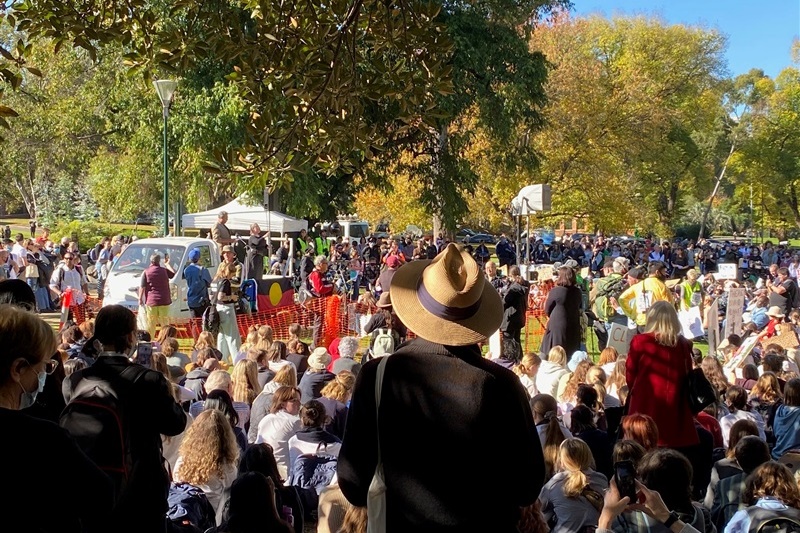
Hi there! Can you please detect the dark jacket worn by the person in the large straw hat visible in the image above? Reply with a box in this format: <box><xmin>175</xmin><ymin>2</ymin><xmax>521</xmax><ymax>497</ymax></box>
<box><xmin>338</xmin><ymin>339</ymin><xmax>544</xmax><ymax>533</ymax></box>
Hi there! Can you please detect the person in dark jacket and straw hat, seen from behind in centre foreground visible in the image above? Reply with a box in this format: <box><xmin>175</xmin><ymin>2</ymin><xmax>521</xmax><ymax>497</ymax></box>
<box><xmin>337</xmin><ymin>243</ymin><xmax>545</xmax><ymax>533</ymax></box>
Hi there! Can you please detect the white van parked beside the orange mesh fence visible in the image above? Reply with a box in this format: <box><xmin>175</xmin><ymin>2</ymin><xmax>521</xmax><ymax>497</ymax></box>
<box><xmin>103</xmin><ymin>237</ymin><xmax>220</xmax><ymax>318</ymax></box>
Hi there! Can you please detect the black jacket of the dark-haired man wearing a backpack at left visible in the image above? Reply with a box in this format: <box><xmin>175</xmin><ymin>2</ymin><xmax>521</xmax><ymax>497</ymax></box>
<box><xmin>63</xmin><ymin>354</ymin><xmax>186</xmax><ymax>532</ymax></box>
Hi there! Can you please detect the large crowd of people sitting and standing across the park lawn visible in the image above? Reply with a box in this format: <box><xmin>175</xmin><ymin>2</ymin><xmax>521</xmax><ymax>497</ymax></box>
<box><xmin>7</xmin><ymin>218</ymin><xmax>800</xmax><ymax>533</ymax></box>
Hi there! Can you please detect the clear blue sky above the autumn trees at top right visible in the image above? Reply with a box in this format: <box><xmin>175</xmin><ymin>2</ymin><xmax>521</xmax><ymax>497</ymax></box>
<box><xmin>572</xmin><ymin>0</ymin><xmax>800</xmax><ymax>77</ymax></box>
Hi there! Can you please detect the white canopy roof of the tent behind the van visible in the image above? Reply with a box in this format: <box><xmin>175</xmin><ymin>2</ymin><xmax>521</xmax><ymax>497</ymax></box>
<box><xmin>181</xmin><ymin>197</ymin><xmax>308</xmax><ymax>233</ymax></box>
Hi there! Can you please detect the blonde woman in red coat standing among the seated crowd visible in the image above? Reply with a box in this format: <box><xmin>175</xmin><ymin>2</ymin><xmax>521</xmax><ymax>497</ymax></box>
<box><xmin>625</xmin><ymin>301</ymin><xmax>699</xmax><ymax>448</ymax></box>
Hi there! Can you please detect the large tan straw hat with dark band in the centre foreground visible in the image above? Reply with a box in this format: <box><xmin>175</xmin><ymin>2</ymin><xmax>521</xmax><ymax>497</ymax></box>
<box><xmin>391</xmin><ymin>243</ymin><xmax>503</xmax><ymax>346</ymax></box>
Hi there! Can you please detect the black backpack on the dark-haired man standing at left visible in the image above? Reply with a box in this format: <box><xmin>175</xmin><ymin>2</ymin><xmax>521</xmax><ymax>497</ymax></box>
<box><xmin>58</xmin><ymin>364</ymin><xmax>147</xmax><ymax>500</ymax></box>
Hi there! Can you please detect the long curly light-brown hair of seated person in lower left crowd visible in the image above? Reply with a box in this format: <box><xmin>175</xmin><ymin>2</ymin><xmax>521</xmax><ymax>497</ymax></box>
<box><xmin>175</xmin><ymin>409</ymin><xmax>239</xmax><ymax>485</ymax></box>
